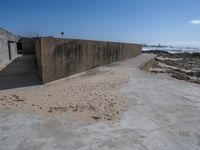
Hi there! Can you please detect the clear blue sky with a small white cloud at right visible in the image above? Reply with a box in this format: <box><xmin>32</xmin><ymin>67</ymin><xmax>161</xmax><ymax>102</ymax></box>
<box><xmin>0</xmin><ymin>0</ymin><xmax>200</xmax><ymax>47</ymax></box>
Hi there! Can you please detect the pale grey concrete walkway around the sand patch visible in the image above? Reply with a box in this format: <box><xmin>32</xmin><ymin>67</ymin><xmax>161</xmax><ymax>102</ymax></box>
<box><xmin>0</xmin><ymin>55</ymin><xmax>200</xmax><ymax>150</ymax></box>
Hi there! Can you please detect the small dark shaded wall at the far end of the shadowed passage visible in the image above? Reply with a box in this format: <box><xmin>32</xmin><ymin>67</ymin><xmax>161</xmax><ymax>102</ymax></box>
<box><xmin>20</xmin><ymin>37</ymin><xmax>36</xmax><ymax>54</ymax></box>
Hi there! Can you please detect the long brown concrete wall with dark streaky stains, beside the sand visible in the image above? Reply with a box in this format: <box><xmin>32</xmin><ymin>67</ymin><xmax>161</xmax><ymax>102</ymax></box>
<box><xmin>36</xmin><ymin>37</ymin><xmax>142</xmax><ymax>83</ymax></box>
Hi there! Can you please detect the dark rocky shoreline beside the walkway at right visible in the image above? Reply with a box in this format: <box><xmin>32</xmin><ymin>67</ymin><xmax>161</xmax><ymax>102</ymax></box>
<box><xmin>144</xmin><ymin>50</ymin><xmax>200</xmax><ymax>84</ymax></box>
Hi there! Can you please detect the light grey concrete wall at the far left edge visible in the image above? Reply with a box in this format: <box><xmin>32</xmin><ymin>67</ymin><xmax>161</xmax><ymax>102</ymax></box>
<box><xmin>0</xmin><ymin>28</ymin><xmax>18</xmax><ymax>66</ymax></box>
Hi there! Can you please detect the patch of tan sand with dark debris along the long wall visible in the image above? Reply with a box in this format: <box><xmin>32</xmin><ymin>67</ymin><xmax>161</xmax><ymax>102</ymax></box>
<box><xmin>0</xmin><ymin>66</ymin><xmax>130</xmax><ymax>122</ymax></box>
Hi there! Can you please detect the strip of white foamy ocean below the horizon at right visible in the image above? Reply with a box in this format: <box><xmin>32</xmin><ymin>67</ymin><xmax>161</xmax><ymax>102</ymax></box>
<box><xmin>142</xmin><ymin>46</ymin><xmax>200</xmax><ymax>53</ymax></box>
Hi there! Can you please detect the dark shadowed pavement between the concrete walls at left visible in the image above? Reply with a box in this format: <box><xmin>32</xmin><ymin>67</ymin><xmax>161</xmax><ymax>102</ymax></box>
<box><xmin>0</xmin><ymin>55</ymin><xmax>42</xmax><ymax>90</ymax></box>
